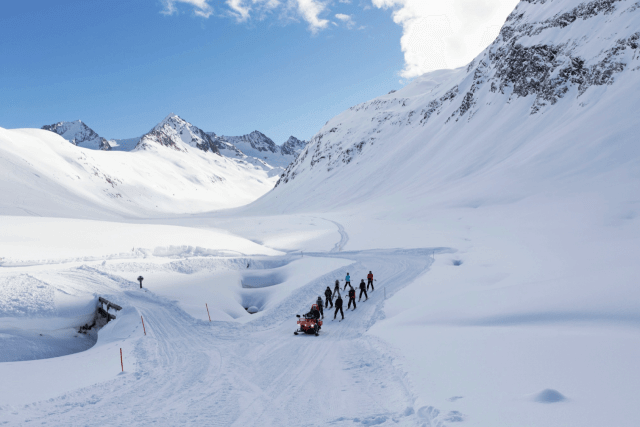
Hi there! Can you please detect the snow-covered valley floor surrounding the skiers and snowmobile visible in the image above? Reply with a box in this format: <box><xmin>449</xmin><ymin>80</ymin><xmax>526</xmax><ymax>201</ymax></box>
<box><xmin>0</xmin><ymin>198</ymin><xmax>640</xmax><ymax>426</ymax></box>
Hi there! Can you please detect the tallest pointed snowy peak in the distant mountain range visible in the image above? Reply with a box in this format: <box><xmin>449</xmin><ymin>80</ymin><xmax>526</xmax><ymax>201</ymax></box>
<box><xmin>135</xmin><ymin>113</ymin><xmax>220</xmax><ymax>154</ymax></box>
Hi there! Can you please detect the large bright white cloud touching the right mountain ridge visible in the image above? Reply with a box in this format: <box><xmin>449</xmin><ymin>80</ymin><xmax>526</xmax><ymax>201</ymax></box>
<box><xmin>371</xmin><ymin>0</ymin><xmax>519</xmax><ymax>78</ymax></box>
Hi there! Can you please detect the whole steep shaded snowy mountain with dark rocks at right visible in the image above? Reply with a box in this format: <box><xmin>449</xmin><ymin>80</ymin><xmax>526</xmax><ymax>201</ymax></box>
<box><xmin>267</xmin><ymin>0</ymin><xmax>640</xmax><ymax>212</ymax></box>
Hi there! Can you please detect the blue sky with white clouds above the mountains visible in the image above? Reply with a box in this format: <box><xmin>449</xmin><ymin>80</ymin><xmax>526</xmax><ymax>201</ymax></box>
<box><xmin>0</xmin><ymin>0</ymin><xmax>518</xmax><ymax>144</ymax></box>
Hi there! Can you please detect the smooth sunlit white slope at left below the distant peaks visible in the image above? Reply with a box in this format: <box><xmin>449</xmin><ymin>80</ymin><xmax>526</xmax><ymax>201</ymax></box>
<box><xmin>0</xmin><ymin>124</ymin><xmax>276</xmax><ymax>218</ymax></box>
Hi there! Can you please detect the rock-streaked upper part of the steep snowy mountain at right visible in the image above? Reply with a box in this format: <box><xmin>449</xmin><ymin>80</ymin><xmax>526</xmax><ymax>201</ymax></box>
<box><xmin>276</xmin><ymin>0</ymin><xmax>640</xmax><ymax>186</ymax></box>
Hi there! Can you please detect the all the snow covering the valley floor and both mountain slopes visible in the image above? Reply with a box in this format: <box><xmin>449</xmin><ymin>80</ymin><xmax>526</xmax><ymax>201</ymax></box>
<box><xmin>0</xmin><ymin>0</ymin><xmax>640</xmax><ymax>427</ymax></box>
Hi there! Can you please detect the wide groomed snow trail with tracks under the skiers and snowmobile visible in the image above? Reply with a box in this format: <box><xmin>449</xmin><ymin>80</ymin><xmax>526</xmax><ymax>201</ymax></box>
<box><xmin>0</xmin><ymin>246</ymin><xmax>456</xmax><ymax>426</ymax></box>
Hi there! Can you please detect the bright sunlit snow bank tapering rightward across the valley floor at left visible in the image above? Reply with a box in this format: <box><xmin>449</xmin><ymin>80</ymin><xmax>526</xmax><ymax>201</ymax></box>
<box><xmin>0</xmin><ymin>216</ymin><xmax>280</xmax><ymax>266</ymax></box>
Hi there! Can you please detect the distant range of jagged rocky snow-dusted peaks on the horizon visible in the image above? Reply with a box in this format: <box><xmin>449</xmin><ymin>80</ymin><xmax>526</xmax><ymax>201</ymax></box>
<box><xmin>42</xmin><ymin>114</ymin><xmax>307</xmax><ymax>172</ymax></box>
